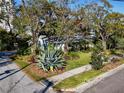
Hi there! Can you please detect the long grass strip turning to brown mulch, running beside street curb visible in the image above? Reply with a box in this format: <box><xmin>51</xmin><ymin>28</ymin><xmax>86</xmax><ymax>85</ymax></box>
<box><xmin>54</xmin><ymin>59</ymin><xmax>124</xmax><ymax>89</ymax></box>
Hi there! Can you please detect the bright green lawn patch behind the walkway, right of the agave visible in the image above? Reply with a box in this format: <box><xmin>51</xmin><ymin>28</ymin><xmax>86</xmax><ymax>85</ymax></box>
<box><xmin>66</xmin><ymin>52</ymin><xmax>91</xmax><ymax>71</ymax></box>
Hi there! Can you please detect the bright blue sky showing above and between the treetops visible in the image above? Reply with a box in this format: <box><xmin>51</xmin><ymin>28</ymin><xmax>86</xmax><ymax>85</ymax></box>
<box><xmin>16</xmin><ymin>0</ymin><xmax>124</xmax><ymax>14</ymax></box>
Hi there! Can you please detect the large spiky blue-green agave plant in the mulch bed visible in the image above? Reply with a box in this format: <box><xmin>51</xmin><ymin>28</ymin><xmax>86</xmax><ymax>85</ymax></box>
<box><xmin>37</xmin><ymin>48</ymin><xmax>66</xmax><ymax>71</ymax></box>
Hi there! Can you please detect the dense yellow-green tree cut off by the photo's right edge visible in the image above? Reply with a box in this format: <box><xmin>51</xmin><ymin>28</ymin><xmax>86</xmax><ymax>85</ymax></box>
<box><xmin>107</xmin><ymin>13</ymin><xmax>124</xmax><ymax>49</ymax></box>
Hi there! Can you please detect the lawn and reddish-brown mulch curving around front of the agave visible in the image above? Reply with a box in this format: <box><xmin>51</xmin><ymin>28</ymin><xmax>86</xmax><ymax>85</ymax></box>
<box><xmin>14</xmin><ymin>52</ymin><xmax>90</xmax><ymax>81</ymax></box>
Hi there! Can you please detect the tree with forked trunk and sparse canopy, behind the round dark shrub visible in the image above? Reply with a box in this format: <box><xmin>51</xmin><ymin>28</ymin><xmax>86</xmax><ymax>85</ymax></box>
<box><xmin>85</xmin><ymin>4</ymin><xmax>118</xmax><ymax>51</ymax></box>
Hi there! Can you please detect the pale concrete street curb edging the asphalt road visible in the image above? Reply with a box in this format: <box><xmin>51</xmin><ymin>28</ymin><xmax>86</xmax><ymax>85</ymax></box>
<box><xmin>61</xmin><ymin>64</ymin><xmax>124</xmax><ymax>93</ymax></box>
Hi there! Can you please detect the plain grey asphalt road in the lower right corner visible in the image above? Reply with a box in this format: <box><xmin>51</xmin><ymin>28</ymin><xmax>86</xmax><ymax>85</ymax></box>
<box><xmin>84</xmin><ymin>70</ymin><xmax>124</xmax><ymax>93</ymax></box>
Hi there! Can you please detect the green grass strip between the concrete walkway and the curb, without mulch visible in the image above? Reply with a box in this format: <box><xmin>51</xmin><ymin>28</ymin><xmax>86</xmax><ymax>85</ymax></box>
<box><xmin>54</xmin><ymin>70</ymin><xmax>103</xmax><ymax>89</ymax></box>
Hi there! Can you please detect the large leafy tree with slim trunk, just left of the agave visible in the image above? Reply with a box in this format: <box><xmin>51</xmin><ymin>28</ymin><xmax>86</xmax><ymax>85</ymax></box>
<box><xmin>13</xmin><ymin>0</ymin><xmax>51</xmax><ymax>55</ymax></box>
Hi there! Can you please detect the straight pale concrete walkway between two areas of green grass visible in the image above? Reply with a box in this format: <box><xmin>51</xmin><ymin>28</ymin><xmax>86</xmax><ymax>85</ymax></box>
<box><xmin>48</xmin><ymin>65</ymin><xmax>92</xmax><ymax>85</ymax></box>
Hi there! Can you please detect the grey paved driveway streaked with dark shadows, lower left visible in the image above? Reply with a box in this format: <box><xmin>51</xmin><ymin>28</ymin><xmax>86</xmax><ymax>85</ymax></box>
<box><xmin>0</xmin><ymin>57</ymin><xmax>53</xmax><ymax>93</ymax></box>
